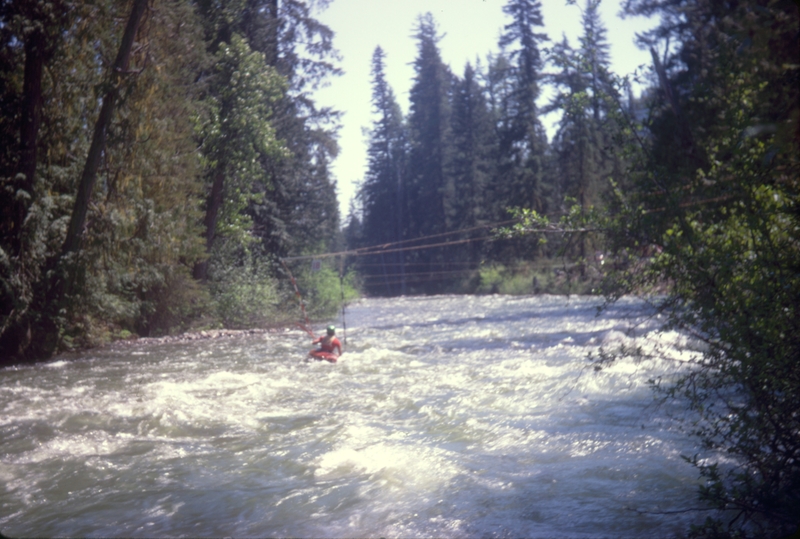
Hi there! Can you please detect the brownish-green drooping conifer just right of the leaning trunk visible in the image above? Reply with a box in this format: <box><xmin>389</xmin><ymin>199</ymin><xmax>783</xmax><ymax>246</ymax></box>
<box><xmin>76</xmin><ymin>0</ymin><xmax>206</xmax><ymax>334</ymax></box>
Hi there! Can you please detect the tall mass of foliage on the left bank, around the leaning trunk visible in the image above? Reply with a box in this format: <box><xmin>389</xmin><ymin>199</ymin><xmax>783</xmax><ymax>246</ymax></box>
<box><xmin>0</xmin><ymin>0</ymin><xmax>338</xmax><ymax>364</ymax></box>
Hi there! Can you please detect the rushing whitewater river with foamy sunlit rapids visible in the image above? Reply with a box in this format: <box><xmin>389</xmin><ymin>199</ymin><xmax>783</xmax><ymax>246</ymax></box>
<box><xmin>0</xmin><ymin>295</ymin><xmax>697</xmax><ymax>538</ymax></box>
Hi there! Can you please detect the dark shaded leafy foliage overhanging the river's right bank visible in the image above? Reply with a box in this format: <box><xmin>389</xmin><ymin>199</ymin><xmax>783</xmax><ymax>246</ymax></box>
<box><xmin>592</xmin><ymin>1</ymin><xmax>800</xmax><ymax>537</ymax></box>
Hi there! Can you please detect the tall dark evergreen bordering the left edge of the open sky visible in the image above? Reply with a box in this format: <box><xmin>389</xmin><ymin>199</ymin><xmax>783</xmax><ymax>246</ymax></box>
<box><xmin>241</xmin><ymin>0</ymin><xmax>340</xmax><ymax>254</ymax></box>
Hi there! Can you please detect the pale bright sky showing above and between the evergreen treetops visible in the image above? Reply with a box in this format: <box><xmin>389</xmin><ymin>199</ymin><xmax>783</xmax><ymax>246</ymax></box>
<box><xmin>315</xmin><ymin>0</ymin><xmax>657</xmax><ymax>221</ymax></box>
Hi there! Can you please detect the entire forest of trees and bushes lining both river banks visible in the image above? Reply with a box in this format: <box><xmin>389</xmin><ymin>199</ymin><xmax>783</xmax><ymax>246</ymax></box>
<box><xmin>0</xmin><ymin>0</ymin><xmax>800</xmax><ymax>537</ymax></box>
